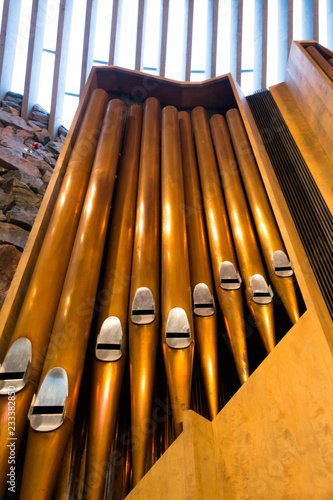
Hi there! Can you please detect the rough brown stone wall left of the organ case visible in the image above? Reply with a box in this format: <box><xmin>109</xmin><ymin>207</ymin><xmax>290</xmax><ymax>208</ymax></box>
<box><xmin>0</xmin><ymin>92</ymin><xmax>67</xmax><ymax>309</ymax></box>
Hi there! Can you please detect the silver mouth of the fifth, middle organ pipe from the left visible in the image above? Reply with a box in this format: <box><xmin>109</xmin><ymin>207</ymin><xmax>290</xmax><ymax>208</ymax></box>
<box><xmin>165</xmin><ymin>307</ymin><xmax>192</xmax><ymax>349</ymax></box>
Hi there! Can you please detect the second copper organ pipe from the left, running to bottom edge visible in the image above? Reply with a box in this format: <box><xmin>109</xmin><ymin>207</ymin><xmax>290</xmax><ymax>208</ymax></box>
<box><xmin>20</xmin><ymin>99</ymin><xmax>124</xmax><ymax>500</ymax></box>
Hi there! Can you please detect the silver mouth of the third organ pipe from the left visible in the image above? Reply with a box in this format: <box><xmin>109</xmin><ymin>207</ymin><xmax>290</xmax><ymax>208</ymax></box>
<box><xmin>95</xmin><ymin>316</ymin><xmax>124</xmax><ymax>361</ymax></box>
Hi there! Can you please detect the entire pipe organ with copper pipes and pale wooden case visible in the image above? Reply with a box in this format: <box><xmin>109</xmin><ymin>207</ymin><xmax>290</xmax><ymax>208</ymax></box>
<box><xmin>0</xmin><ymin>42</ymin><xmax>333</xmax><ymax>499</ymax></box>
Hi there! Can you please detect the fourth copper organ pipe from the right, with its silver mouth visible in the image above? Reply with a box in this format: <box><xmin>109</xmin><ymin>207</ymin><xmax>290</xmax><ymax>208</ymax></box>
<box><xmin>178</xmin><ymin>111</ymin><xmax>218</xmax><ymax>419</ymax></box>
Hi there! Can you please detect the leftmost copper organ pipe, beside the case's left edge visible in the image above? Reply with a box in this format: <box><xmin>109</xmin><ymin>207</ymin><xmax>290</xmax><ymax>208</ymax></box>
<box><xmin>0</xmin><ymin>90</ymin><xmax>108</xmax><ymax>497</ymax></box>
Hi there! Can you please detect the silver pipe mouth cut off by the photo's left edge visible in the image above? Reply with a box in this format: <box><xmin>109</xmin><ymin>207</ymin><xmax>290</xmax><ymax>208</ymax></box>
<box><xmin>0</xmin><ymin>337</ymin><xmax>32</xmax><ymax>394</ymax></box>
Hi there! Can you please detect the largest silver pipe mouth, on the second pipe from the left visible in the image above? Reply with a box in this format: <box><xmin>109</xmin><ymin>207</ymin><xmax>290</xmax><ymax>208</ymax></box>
<box><xmin>28</xmin><ymin>367</ymin><xmax>68</xmax><ymax>432</ymax></box>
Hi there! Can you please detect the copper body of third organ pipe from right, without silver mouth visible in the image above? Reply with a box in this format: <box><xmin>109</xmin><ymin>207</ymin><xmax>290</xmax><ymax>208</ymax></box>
<box><xmin>191</xmin><ymin>107</ymin><xmax>249</xmax><ymax>383</ymax></box>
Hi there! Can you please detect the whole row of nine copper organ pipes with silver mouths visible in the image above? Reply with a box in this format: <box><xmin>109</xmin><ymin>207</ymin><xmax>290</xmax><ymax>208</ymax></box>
<box><xmin>0</xmin><ymin>89</ymin><xmax>299</xmax><ymax>500</ymax></box>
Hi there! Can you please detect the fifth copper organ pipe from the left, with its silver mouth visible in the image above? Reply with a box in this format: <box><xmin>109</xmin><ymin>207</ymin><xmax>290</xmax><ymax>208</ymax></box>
<box><xmin>161</xmin><ymin>106</ymin><xmax>194</xmax><ymax>435</ymax></box>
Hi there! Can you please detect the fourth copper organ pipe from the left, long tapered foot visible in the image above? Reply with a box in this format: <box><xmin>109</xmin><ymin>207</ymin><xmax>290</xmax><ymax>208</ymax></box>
<box><xmin>129</xmin><ymin>97</ymin><xmax>161</xmax><ymax>486</ymax></box>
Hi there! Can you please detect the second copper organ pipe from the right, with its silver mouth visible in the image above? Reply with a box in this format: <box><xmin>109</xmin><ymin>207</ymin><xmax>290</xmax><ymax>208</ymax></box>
<box><xmin>210</xmin><ymin>115</ymin><xmax>275</xmax><ymax>353</ymax></box>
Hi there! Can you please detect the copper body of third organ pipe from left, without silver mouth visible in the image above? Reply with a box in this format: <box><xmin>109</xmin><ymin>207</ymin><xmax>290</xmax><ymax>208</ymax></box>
<box><xmin>85</xmin><ymin>105</ymin><xmax>142</xmax><ymax>500</ymax></box>
